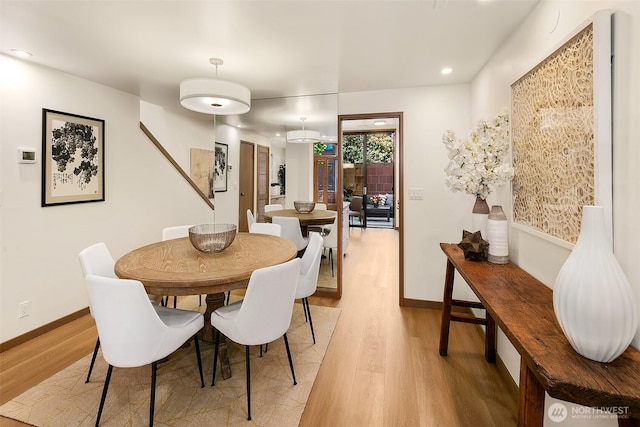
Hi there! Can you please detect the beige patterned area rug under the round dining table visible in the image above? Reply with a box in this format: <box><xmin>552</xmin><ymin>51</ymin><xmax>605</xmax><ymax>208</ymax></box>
<box><xmin>0</xmin><ymin>304</ymin><xmax>340</xmax><ymax>427</ymax></box>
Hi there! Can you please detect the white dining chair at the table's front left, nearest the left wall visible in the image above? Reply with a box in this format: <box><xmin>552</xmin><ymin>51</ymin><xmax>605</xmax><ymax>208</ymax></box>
<box><xmin>85</xmin><ymin>274</ymin><xmax>204</xmax><ymax>426</ymax></box>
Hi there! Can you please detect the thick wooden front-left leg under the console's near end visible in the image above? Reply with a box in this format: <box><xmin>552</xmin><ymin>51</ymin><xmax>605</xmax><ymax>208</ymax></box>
<box><xmin>518</xmin><ymin>360</ymin><xmax>544</xmax><ymax>427</ymax></box>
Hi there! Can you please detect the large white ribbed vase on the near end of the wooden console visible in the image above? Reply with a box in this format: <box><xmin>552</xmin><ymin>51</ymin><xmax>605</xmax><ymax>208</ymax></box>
<box><xmin>553</xmin><ymin>206</ymin><xmax>638</xmax><ymax>363</ymax></box>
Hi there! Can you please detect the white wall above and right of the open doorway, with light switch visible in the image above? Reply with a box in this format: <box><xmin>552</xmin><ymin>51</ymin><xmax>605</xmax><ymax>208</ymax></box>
<box><xmin>340</xmin><ymin>85</ymin><xmax>475</xmax><ymax>301</ymax></box>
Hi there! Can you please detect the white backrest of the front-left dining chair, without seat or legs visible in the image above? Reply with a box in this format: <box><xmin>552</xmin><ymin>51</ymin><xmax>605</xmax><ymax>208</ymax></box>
<box><xmin>85</xmin><ymin>275</ymin><xmax>178</xmax><ymax>368</ymax></box>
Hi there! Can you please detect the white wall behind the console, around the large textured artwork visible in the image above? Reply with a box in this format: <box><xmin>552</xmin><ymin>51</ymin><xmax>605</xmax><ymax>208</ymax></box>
<box><xmin>471</xmin><ymin>1</ymin><xmax>640</xmax><ymax>426</ymax></box>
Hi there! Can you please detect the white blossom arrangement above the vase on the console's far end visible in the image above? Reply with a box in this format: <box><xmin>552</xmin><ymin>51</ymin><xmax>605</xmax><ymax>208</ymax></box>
<box><xmin>442</xmin><ymin>113</ymin><xmax>513</xmax><ymax>200</ymax></box>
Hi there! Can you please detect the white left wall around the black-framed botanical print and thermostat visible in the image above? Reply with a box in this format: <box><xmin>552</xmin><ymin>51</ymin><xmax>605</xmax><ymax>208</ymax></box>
<box><xmin>0</xmin><ymin>54</ymin><xmax>210</xmax><ymax>342</ymax></box>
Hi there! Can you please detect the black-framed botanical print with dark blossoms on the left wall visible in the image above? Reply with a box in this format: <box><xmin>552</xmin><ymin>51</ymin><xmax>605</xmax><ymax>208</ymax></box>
<box><xmin>42</xmin><ymin>108</ymin><xmax>104</xmax><ymax>206</ymax></box>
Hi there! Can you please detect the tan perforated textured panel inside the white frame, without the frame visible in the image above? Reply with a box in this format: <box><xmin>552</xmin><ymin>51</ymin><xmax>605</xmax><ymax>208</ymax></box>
<box><xmin>511</xmin><ymin>24</ymin><xmax>596</xmax><ymax>243</ymax></box>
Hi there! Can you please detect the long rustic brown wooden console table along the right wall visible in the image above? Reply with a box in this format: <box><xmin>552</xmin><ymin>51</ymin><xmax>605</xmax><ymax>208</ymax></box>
<box><xmin>440</xmin><ymin>243</ymin><xmax>640</xmax><ymax>427</ymax></box>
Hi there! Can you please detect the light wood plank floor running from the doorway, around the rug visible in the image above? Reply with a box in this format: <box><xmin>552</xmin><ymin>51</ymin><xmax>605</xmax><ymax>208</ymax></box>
<box><xmin>0</xmin><ymin>229</ymin><xmax>517</xmax><ymax>427</ymax></box>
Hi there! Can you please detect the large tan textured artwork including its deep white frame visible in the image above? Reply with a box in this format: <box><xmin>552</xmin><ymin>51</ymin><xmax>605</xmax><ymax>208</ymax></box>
<box><xmin>511</xmin><ymin>11</ymin><xmax>612</xmax><ymax>248</ymax></box>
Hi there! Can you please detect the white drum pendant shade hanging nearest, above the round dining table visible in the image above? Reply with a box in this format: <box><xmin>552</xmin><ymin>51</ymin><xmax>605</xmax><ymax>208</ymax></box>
<box><xmin>180</xmin><ymin>78</ymin><xmax>251</xmax><ymax>116</ymax></box>
